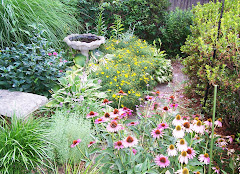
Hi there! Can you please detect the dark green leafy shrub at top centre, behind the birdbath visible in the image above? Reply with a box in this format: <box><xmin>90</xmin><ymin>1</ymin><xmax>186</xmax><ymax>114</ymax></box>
<box><xmin>103</xmin><ymin>0</ymin><xmax>170</xmax><ymax>41</ymax></box>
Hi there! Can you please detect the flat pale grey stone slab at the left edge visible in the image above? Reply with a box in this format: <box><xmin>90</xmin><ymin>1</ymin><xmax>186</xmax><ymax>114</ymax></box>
<box><xmin>0</xmin><ymin>90</ymin><xmax>48</xmax><ymax>118</ymax></box>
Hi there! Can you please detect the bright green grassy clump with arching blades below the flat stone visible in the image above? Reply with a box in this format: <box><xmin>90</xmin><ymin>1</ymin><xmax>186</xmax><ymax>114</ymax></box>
<box><xmin>0</xmin><ymin>116</ymin><xmax>51</xmax><ymax>174</ymax></box>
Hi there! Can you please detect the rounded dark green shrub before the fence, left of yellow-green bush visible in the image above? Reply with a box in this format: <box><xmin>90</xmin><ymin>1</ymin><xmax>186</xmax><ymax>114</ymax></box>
<box><xmin>160</xmin><ymin>8</ymin><xmax>193</xmax><ymax>57</ymax></box>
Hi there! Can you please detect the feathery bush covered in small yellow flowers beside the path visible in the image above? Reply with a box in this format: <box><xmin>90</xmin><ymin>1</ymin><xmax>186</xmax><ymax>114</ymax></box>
<box><xmin>90</xmin><ymin>36</ymin><xmax>171</xmax><ymax>109</ymax></box>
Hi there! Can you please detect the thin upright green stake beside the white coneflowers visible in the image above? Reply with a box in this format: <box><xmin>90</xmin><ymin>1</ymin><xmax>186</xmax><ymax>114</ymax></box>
<box><xmin>208</xmin><ymin>85</ymin><xmax>217</xmax><ymax>174</ymax></box>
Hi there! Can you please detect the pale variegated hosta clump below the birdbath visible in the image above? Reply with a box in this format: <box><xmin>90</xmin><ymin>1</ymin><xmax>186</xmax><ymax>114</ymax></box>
<box><xmin>47</xmin><ymin>69</ymin><xmax>106</xmax><ymax>113</ymax></box>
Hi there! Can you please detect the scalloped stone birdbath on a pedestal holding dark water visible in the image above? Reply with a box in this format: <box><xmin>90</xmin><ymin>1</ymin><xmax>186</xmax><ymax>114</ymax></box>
<box><xmin>63</xmin><ymin>33</ymin><xmax>105</xmax><ymax>64</ymax></box>
